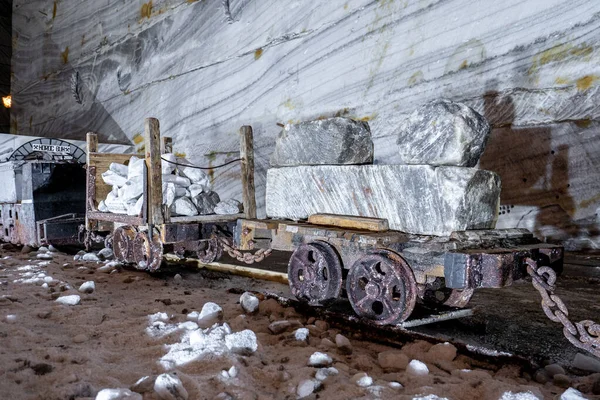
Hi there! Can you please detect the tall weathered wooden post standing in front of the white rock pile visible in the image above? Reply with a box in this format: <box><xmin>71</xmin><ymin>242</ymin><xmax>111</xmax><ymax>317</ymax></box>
<box><xmin>144</xmin><ymin>118</ymin><xmax>164</xmax><ymax>225</ymax></box>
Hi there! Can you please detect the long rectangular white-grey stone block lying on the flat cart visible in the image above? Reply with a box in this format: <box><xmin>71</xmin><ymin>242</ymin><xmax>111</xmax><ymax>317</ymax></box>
<box><xmin>266</xmin><ymin>165</ymin><xmax>500</xmax><ymax>236</ymax></box>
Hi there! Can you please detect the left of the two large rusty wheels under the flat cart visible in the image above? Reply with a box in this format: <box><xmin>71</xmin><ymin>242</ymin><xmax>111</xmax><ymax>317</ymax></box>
<box><xmin>288</xmin><ymin>241</ymin><xmax>342</xmax><ymax>306</ymax></box>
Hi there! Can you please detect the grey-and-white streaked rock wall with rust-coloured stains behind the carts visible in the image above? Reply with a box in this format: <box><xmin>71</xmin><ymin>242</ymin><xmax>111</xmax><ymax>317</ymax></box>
<box><xmin>11</xmin><ymin>0</ymin><xmax>600</xmax><ymax>248</ymax></box>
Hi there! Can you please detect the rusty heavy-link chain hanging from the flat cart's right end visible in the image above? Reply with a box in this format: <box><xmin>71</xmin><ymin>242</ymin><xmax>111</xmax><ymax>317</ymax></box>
<box><xmin>525</xmin><ymin>258</ymin><xmax>600</xmax><ymax>358</ymax></box>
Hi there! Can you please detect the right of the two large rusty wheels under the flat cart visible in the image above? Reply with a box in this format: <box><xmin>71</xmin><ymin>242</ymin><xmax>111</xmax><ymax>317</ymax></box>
<box><xmin>346</xmin><ymin>249</ymin><xmax>417</xmax><ymax>325</ymax></box>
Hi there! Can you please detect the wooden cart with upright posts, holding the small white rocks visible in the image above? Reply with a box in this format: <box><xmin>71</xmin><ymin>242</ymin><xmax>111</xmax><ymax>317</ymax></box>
<box><xmin>85</xmin><ymin>118</ymin><xmax>256</xmax><ymax>271</ymax></box>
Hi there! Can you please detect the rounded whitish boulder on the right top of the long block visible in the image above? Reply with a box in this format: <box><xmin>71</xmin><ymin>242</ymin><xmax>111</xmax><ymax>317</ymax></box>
<box><xmin>397</xmin><ymin>99</ymin><xmax>490</xmax><ymax>167</ymax></box>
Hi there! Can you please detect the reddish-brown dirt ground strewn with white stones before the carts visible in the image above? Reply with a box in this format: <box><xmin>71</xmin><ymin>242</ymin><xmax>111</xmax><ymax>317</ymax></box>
<box><xmin>0</xmin><ymin>249</ymin><xmax>600</xmax><ymax>400</ymax></box>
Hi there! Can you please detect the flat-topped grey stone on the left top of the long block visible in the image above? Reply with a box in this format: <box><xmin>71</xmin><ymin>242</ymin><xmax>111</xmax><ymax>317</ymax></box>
<box><xmin>271</xmin><ymin>117</ymin><xmax>373</xmax><ymax>167</ymax></box>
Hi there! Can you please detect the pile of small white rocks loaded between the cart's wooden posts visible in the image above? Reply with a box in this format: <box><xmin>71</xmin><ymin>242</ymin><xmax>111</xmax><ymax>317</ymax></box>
<box><xmin>98</xmin><ymin>153</ymin><xmax>242</xmax><ymax>217</ymax></box>
